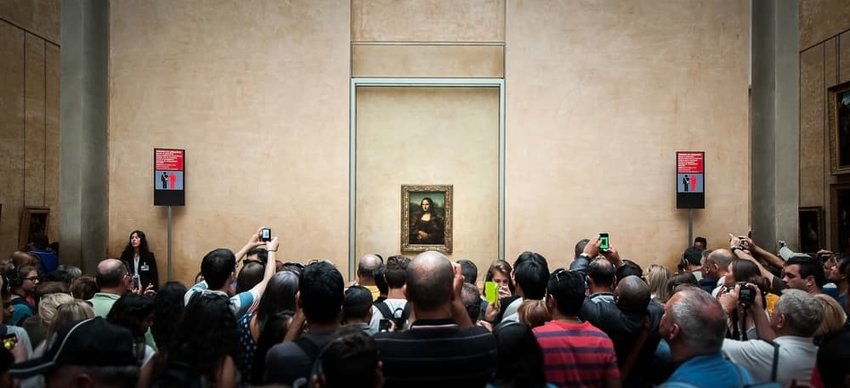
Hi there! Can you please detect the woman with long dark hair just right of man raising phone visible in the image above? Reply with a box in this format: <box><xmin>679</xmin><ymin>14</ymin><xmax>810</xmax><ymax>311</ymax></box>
<box><xmin>238</xmin><ymin>271</ymin><xmax>298</xmax><ymax>385</ymax></box>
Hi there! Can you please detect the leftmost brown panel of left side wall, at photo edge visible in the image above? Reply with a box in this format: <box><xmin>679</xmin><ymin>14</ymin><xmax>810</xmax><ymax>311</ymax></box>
<box><xmin>0</xmin><ymin>21</ymin><xmax>26</xmax><ymax>254</ymax></box>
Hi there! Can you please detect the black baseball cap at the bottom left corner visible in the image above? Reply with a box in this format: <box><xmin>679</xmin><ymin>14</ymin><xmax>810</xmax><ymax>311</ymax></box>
<box><xmin>9</xmin><ymin>317</ymin><xmax>137</xmax><ymax>378</ymax></box>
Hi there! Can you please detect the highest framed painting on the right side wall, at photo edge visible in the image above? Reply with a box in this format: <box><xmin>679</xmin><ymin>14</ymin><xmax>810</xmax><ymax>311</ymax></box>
<box><xmin>827</xmin><ymin>82</ymin><xmax>850</xmax><ymax>174</ymax></box>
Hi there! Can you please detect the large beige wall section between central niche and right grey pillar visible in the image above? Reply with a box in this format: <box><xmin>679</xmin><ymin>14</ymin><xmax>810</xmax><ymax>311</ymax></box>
<box><xmin>505</xmin><ymin>0</ymin><xmax>750</xmax><ymax>268</ymax></box>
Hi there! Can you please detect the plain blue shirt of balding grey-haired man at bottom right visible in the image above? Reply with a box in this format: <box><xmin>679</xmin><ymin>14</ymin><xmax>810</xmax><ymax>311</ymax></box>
<box><xmin>661</xmin><ymin>352</ymin><xmax>753</xmax><ymax>388</ymax></box>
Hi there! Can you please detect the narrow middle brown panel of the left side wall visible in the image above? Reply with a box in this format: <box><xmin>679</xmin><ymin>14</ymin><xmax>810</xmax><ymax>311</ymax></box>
<box><xmin>24</xmin><ymin>34</ymin><xmax>46</xmax><ymax>206</ymax></box>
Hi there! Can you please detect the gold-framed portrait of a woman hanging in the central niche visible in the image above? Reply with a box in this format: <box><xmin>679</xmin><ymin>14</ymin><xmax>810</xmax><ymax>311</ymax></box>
<box><xmin>401</xmin><ymin>185</ymin><xmax>452</xmax><ymax>253</ymax></box>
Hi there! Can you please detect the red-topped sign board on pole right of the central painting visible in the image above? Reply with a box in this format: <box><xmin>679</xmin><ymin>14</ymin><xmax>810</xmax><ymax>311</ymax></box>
<box><xmin>676</xmin><ymin>151</ymin><xmax>705</xmax><ymax>209</ymax></box>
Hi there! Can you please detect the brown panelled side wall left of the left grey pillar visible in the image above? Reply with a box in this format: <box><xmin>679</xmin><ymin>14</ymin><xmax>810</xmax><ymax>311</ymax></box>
<box><xmin>0</xmin><ymin>0</ymin><xmax>60</xmax><ymax>255</ymax></box>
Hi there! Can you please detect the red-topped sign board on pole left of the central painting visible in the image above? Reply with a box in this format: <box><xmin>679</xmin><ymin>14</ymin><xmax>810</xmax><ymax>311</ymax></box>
<box><xmin>153</xmin><ymin>148</ymin><xmax>186</xmax><ymax>206</ymax></box>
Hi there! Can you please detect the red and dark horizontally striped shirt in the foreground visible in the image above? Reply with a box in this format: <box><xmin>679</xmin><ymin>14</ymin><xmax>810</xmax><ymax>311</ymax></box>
<box><xmin>534</xmin><ymin>321</ymin><xmax>620</xmax><ymax>387</ymax></box>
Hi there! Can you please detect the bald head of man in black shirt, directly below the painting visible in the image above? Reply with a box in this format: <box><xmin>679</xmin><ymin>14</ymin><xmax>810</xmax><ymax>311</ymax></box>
<box><xmin>407</xmin><ymin>251</ymin><xmax>454</xmax><ymax>311</ymax></box>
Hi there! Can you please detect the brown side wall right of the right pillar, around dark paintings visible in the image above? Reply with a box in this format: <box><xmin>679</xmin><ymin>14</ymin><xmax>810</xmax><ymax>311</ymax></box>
<box><xmin>800</xmin><ymin>0</ymin><xmax>850</xmax><ymax>249</ymax></box>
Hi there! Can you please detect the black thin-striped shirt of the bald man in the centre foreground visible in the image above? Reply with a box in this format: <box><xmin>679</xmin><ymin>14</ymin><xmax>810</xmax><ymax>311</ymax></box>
<box><xmin>374</xmin><ymin>319</ymin><xmax>496</xmax><ymax>388</ymax></box>
